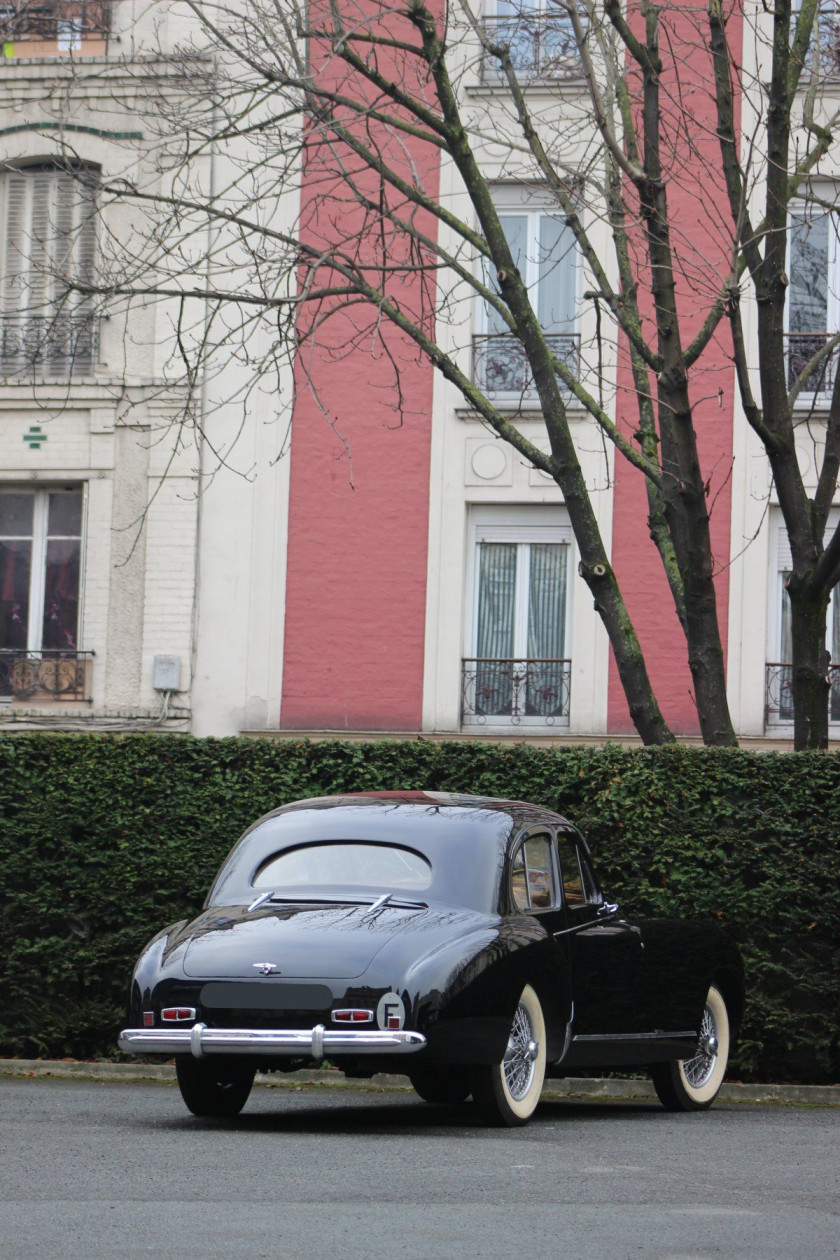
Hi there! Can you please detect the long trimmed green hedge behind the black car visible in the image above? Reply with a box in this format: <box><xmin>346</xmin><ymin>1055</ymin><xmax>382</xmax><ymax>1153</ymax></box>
<box><xmin>0</xmin><ymin>735</ymin><xmax>840</xmax><ymax>1082</ymax></box>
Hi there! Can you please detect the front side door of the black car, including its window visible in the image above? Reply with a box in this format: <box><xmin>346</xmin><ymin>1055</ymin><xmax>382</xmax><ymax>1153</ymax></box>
<box><xmin>555</xmin><ymin>829</ymin><xmax>650</xmax><ymax>1043</ymax></box>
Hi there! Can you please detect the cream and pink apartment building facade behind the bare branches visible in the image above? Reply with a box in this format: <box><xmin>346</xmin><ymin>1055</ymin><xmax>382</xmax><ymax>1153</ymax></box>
<box><xmin>0</xmin><ymin>0</ymin><xmax>840</xmax><ymax>741</ymax></box>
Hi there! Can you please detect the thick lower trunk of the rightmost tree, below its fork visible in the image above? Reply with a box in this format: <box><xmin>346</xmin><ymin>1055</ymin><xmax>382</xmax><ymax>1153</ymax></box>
<box><xmin>787</xmin><ymin>573</ymin><xmax>831</xmax><ymax>752</ymax></box>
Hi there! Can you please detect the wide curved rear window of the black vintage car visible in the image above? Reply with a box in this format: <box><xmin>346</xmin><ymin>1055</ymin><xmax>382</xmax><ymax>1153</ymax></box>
<box><xmin>251</xmin><ymin>840</ymin><xmax>432</xmax><ymax>892</ymax></box>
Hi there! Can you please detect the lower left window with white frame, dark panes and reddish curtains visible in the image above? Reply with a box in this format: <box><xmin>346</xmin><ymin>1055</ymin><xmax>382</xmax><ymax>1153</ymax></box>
<box><xmin>0</xmin><ymin>486</ymin><xmax>89</xmax><ymax>699</ymax></box>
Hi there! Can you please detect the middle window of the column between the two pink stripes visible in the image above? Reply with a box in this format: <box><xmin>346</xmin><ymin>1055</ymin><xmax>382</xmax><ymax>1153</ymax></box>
<box><xmin>474</xmin><ymin>190</ymin><xmax>579</xmax><ymax>398</ymax></box>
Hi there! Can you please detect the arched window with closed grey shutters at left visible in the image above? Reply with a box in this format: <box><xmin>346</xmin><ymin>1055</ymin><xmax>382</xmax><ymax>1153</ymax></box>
<box><xmin>0</xmin><ymin>164</ymin><xmax>97</xmax><ymax>375</ymax></box>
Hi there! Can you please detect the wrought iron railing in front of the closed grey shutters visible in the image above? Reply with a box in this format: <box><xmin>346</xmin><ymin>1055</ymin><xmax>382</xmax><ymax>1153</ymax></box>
<box><xmin>0</xmin><ymin>312</ymin><xmax>99</xmax><ymax>375</ymax></box>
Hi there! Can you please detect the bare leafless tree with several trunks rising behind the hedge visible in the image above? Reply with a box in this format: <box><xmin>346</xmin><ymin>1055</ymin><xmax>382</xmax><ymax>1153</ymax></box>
<box><xmin>40</xmin><ymin>0</ymin><xmax>840</xmax><ymax>747</ymax></box>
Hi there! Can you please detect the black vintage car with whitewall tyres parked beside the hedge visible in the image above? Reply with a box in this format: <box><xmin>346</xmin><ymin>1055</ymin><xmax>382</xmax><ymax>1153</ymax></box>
<box><xmin>120</xmin><ymin>791</ymin><xmax>744</xmax><ymax>1125</ymax></box>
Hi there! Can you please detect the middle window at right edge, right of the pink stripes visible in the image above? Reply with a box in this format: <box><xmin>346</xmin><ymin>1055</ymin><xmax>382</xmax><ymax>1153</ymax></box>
<box><xmin>787</xmin><ymin>205</ymin><xmax>840</xmax><ymax>393</ymax></box>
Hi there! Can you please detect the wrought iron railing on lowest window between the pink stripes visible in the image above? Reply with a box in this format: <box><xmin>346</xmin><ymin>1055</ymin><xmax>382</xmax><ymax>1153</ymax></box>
<box><xmin>461</xmin><ymin>656</ymin><xmax>572</xmax><ymax>726</ymax></box>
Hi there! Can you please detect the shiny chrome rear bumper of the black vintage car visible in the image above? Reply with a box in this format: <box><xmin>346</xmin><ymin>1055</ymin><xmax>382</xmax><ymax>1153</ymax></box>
<box><xmin>117</xmin><ymin>1023</ymin><xmax>426</xmax><ymax>1058</ymax></box>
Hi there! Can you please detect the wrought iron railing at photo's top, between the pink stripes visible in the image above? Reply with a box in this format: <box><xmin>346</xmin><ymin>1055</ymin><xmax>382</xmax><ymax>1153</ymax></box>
<box><xmin>481</xmin><ymin>11</ymin><xmax>581</xmax><ymax>83</ymax></box>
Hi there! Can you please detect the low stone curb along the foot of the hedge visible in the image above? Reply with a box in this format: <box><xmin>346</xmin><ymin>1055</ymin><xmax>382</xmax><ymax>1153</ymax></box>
<box><xmin>0</xmin><ymin>1058</ymin><xmax>840</xmax><ymax>1106</ymax></box>
